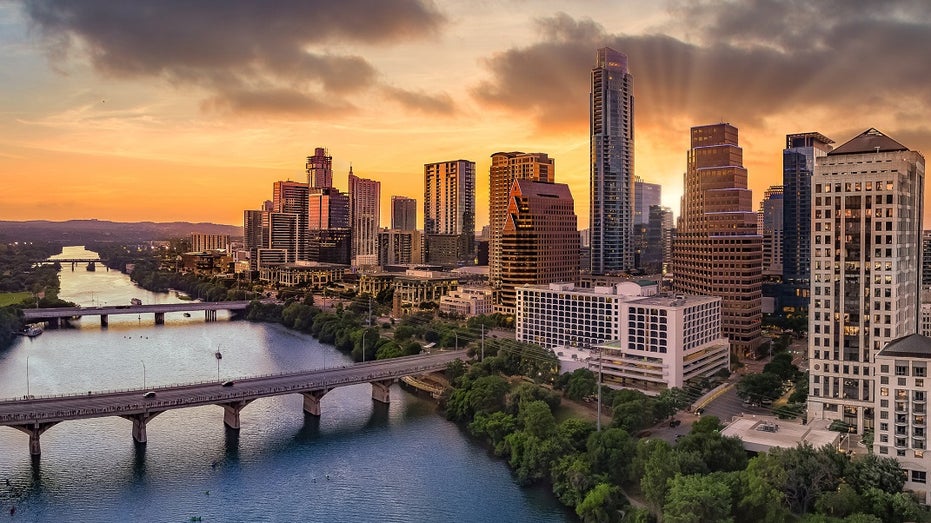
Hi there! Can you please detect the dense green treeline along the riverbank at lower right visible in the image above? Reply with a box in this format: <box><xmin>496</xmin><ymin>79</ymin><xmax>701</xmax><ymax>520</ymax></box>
<box><xmin>445</xmin><ymin>364</ymin><xmax>929</xmax><ymax>523</ymax></box>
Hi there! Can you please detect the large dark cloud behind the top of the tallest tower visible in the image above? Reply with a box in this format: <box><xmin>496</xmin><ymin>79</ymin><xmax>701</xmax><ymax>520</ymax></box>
<box><xmin>472</xmin><ymin>0</ymin><xmax>931</xmax><ymax>145</ymax></box>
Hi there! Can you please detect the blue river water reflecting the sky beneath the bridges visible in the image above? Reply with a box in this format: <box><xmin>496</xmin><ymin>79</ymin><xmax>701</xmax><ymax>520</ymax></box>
<box><xmin>0</xmin><ymin>247</ymin><xmax>570</xmax><ymax>522</ymax></box>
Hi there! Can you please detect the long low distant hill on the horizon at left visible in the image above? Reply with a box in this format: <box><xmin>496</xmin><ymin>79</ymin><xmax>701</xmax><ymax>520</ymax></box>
<box><xmin>0</xmin><ymin>220</ymin><xmax>242</xmax><ymax>245</ymax></box>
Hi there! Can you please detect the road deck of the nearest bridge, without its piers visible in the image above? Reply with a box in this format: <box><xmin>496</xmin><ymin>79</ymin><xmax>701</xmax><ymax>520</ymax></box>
<box><xmin>0</xmin><ymin>351</ymin><xmax>466</xmax><ymax>426</ymax></box>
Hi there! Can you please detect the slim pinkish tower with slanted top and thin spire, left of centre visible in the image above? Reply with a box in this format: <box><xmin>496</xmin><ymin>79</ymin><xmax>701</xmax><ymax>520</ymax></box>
<box><xmin>349</xmin><ymin>167</ymin><xmax>381</xmax><ymax>266</ymax></box>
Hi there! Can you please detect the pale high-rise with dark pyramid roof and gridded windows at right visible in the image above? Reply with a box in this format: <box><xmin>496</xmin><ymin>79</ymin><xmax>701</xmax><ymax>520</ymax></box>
<box><xmin>808</xmin><ymin>129</ymin><xmax>925</xmax><ymax>434</ymax></box>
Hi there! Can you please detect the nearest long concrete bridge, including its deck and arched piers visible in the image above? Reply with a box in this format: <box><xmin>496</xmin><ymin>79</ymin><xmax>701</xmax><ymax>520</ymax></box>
<box><xmin>0</xmin><ymin>351</ymin><xmax>467</xmax><ymax>456</ymax></box>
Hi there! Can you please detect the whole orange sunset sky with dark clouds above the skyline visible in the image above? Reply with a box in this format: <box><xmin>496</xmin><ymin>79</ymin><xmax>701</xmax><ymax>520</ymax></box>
<box><xmin>0</xmin><ymin>0</ymin><xmax>931</xmax><ymax>228</ymax></box>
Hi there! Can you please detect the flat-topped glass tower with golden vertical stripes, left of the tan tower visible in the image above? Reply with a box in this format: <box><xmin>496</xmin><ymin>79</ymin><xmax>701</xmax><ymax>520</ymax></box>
<box><xmin>423</xmin><ymin>160</ymin><xmax>475</xmax><ymax>264</ymax></box>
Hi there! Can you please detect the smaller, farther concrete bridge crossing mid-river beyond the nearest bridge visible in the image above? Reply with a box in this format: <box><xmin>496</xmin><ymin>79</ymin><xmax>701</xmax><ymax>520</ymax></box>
<box><xmin>23</xmin><ymin>301</ymin><xmax>251</xmax><ymax>327</ymax></box>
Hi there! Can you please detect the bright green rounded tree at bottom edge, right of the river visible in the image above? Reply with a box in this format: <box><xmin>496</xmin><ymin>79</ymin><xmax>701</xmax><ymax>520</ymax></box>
<box><xmin>663</xmin><ymin>475</ymin><xmax>733</xmax><ymax>523</ymax></box>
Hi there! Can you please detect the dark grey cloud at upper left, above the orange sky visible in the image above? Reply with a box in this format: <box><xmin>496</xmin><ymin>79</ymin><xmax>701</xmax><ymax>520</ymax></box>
<box><xmin>23</xmin><ymin>0</ymin><xmax>445</xmax><ymax>115</ymax></box>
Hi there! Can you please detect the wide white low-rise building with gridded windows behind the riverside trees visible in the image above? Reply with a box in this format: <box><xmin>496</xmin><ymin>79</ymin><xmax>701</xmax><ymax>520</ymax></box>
<box><xmin>515</xmin><ymin>281</ymin><xmax>730</xmax><ymax>394</ymax></box>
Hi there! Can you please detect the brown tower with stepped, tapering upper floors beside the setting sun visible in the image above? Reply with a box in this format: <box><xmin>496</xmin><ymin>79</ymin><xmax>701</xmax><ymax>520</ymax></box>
<box><xmin>672</xmin><ymin>123</ymin><xmax>763</xmax><ymax>356</ymax></box>
